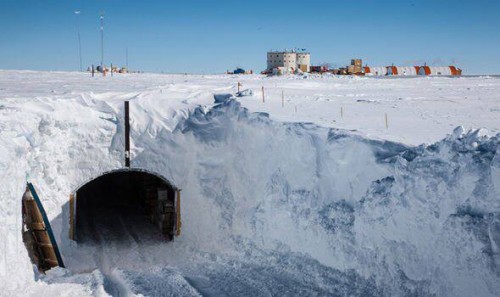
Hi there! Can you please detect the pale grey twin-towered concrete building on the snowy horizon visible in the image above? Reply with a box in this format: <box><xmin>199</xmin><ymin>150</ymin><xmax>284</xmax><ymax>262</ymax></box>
<box><xmin>267</xmin><ymin>51</ymin><xmax>311</xmax><ymax>73</ymax></box>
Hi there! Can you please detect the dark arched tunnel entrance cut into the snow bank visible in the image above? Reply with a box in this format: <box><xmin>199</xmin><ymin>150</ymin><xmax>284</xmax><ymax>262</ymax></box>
<box><xmin>70</xmin><ymin>169</ymin><xmax>180</xmax><ymax>244</ymax></box>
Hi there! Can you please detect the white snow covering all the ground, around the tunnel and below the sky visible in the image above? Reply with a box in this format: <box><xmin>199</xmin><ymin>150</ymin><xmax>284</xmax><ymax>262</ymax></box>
<box><xmin>0</xmin><ymin>71</ymin><xmax>500</xmax><ymax>296</ymax></box>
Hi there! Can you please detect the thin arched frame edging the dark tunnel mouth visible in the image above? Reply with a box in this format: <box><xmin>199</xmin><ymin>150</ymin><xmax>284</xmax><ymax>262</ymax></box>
<box><xmin>68</xmin><ymin>168</ymin><xmax>182</xmax><ymax>241</ymax></box>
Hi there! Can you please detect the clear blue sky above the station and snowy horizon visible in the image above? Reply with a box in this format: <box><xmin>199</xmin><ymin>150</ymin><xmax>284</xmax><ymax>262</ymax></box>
<box><xmin>0</xmin><ymin>0</ymin><xmax>500</xmax><ymax>74</ymax></box>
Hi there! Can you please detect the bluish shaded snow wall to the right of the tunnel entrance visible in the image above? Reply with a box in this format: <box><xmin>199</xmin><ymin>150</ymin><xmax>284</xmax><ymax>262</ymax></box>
<box><xmin>159</xmin><ymin>101</ymin><xmax>500</xmax><ymax>296</ymax></box>
